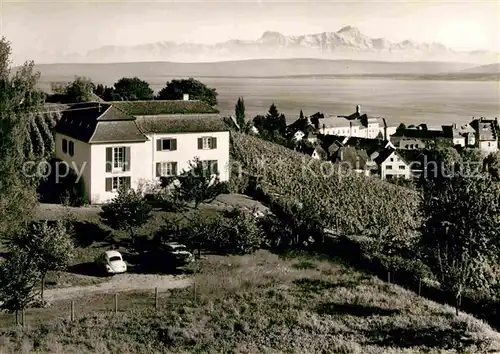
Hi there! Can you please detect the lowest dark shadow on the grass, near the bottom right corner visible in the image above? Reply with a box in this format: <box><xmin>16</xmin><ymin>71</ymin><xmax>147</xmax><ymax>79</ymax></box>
<box><xmin>365</xmin><ymin>322</ymin><xmax>489</xmax><ymax>353</ymax></box>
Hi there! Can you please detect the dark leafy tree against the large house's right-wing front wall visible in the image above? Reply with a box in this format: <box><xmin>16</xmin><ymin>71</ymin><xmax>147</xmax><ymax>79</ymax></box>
<box><xmin>166</xmin><ymin>158</ymin><xmax>224</xmax><ymax>209</ymax></box>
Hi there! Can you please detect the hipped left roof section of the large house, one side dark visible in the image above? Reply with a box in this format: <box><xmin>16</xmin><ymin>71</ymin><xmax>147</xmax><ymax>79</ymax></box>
<box><xmin>55</xmin><ymin>102</ymin><xmax>148</xmax><ymax>143</ymax></box>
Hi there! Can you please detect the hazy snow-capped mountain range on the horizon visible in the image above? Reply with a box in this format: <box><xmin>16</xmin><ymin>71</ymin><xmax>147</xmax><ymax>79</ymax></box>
<box><xmin>31</xmin><ymin>26</ymin><xmax>500</xmax><ymax>64</ymax></box>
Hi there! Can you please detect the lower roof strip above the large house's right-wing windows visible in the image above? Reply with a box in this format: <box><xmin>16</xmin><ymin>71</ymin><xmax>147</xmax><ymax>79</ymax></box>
<box><xmin>136</xmin><ymin>114</ymin><xmax>229</xmax><ymax>134</ymax></box>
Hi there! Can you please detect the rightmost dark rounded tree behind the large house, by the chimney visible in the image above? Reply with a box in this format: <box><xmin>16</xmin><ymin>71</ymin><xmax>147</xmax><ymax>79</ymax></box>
<box><xmin>157</xmin><ymin>78</ymin><xmax>217</xmax><ymax>107</ymax></box>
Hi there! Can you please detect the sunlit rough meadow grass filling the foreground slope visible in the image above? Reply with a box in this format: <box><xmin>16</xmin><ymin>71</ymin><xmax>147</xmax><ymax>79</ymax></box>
<box><xmin>0</xmin><ymin>251</ymin><xmax>500</xmax><ymax>354</ymax></box>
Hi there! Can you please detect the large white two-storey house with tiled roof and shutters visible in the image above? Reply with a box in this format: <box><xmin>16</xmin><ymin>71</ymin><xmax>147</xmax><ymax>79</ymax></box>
<box><xmin>55</xmin><ymin>100</ymin><xmax>229</xmax><ymax>204</ymax></box>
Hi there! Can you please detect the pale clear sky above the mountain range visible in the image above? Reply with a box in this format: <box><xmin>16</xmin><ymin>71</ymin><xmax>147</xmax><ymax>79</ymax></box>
<box><xmin>0</xmin><ymin>0</ymin><xmax>500</xmax><ymax>63</ymax></box>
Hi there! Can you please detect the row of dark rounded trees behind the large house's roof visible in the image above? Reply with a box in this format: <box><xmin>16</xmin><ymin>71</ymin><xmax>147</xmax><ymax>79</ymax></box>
<box><xmin>48</xmin><ymin>76</ymin><xmax>217</xmax><ymax>106</ymax></box>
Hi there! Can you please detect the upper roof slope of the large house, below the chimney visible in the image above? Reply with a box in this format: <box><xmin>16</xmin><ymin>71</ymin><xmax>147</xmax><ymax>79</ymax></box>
<box><xmin>108</xmin><ymin>100</ymin><xmax>219</xmax><ymax>117</ymax></box>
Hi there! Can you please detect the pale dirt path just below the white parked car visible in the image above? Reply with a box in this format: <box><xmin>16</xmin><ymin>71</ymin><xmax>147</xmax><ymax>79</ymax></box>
<box><xmin>44</xmin><ymin>273</ymin><xmax>191</xmax><ymax>302</ymax></box>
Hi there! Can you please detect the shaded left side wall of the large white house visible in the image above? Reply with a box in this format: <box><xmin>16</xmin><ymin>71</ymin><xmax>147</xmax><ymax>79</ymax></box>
<box><xmin>53</xmin><ymin>133</ymin><xmax>92</xmax><ymax>201</ymax></box>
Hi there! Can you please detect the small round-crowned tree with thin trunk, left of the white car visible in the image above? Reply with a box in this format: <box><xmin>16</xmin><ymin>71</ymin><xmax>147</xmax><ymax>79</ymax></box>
<box><xmin>12</xmin><ymin>221</ymin><xmax>74</xmax><ymax>302</ymax></box>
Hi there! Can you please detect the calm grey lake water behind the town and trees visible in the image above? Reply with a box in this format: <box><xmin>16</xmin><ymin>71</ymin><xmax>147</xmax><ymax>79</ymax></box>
<box><xmin>41</xmin><ymin>76</ymin><xmax>500</xmax><ymax>125</ymax></box>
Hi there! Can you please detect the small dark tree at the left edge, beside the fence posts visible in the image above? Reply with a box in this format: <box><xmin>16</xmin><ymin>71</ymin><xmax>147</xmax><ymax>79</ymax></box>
<box><xmin>0</xmin><ymin>247</ymin><xmax>39</xmax><ymax>324</ymax></box>
